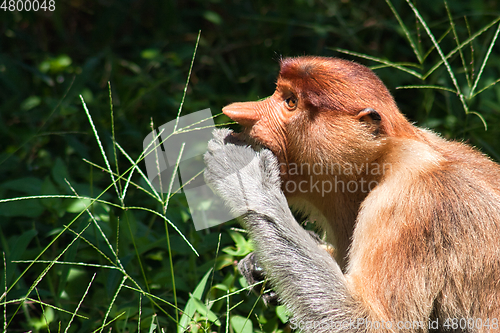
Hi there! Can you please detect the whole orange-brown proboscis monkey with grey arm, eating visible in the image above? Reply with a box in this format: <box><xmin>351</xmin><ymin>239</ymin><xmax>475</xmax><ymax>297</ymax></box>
<box><xmin>205</xmin><ymin>57</ymin><xmax>500</xmax><ymax>333</ymax></box>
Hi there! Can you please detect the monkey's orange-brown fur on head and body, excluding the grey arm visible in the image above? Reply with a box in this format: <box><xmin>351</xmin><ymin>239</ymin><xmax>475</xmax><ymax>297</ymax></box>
<box><xmin>223</xmin><ymin>57</ymin><xmax>500</xmax><ymax>331</ymax></box>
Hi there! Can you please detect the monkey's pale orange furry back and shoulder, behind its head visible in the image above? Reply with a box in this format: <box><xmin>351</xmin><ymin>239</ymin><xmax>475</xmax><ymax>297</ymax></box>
<box><xmin>348</xmin><ymin>131</ymin><xmax>500</xmax><ymax>320</ymax></box>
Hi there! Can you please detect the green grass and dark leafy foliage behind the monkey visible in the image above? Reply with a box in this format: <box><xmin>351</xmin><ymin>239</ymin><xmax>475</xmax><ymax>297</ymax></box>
<box><xmin>0</xmin><ymin>0</ymin><xmax>500</xmax><ymax>333</ymax></box>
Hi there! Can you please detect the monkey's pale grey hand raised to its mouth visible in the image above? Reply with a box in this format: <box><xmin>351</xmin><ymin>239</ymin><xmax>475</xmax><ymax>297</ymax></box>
<box><xmin>204</xmin><ymin>129</ymin><xmax>286</xmax><ymax>217</ymax></box>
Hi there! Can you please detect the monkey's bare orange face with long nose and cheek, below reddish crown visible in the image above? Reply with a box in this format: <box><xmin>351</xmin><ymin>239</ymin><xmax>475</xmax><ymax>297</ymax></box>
<box><xmin>223</xmin><ymin>85</ymin><xmax>380</xmax><ymax>181</ymax></box>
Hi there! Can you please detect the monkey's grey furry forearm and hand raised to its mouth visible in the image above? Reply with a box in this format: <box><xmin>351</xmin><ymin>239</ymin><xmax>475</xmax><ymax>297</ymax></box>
<box><xmin>205</xmin><ymin>130</ymin><xmax>365</xmax><ymax>333</ymax></box>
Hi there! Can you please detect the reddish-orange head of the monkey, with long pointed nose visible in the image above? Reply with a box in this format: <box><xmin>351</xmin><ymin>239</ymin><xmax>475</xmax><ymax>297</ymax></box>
<box><xmin>222</xmin><ymin>57</ymin><xmax>415</xmax><ymax>180</ymax></box>
